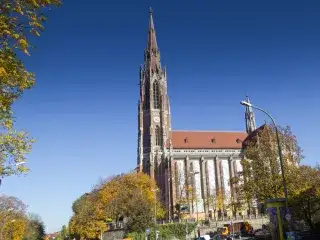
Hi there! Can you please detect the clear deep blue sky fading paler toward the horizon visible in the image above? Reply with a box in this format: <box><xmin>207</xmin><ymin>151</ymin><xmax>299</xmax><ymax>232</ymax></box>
<box><xmin>0</xmin><ymin>0</ymin><xmax>320</xmax><ymax>232</ymax></box>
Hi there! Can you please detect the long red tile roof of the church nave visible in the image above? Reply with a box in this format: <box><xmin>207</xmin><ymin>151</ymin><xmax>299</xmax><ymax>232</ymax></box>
<box><xmin>171</xmin><ymin>131</ymin><xmax>247</xmax><ymax>149</ymax></box>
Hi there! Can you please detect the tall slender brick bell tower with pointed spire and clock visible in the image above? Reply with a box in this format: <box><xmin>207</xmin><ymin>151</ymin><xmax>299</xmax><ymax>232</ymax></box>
<box><xmin>137</xmin><ymin>8</ymin><xmax>171</xmax><ymax>181</ymax></box>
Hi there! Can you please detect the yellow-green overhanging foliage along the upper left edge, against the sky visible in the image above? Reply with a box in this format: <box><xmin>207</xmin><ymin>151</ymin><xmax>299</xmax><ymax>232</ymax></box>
<box><xmin>0</xmin><ymin>0</ymin><xmax>60</xmax><ymax>177</ymax></box>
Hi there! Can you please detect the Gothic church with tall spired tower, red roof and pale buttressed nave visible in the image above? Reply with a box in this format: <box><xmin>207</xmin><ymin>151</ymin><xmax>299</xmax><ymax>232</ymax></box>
<box><xmin>137</xmin><ymin>9</ymin><xmax>256</xmax><ymax>219</ymax></box>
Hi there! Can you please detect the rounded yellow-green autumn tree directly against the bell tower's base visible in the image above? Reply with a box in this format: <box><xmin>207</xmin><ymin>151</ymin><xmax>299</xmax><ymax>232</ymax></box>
<box><xmin>100</xmin><ymin>173</ymin><xmax>165</xmax><ymax>231</ymax></box>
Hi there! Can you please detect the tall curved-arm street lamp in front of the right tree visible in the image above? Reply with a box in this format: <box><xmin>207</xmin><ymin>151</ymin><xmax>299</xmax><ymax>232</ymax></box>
<box><xmin>240</xmin><ymin>101</ymin><xmax>289</xmax><ymax>211</ymax></box>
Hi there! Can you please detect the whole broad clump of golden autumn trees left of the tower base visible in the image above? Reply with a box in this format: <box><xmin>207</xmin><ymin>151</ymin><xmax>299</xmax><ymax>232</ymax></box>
<box><xmin>69</xmin><ymin>173</ymin><xmax>165</xmax><ymax>239</ymax></box>
